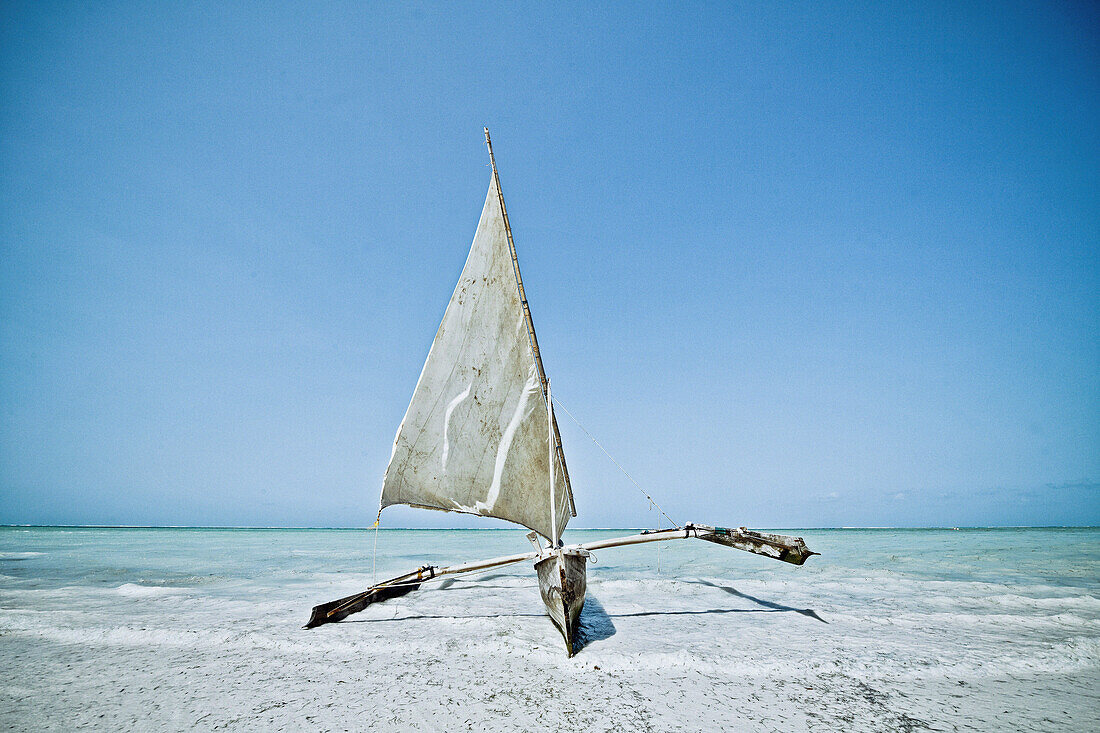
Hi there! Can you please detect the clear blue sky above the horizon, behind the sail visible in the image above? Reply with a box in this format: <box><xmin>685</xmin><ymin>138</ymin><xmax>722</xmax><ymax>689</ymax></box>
<box><xmin>0</xmin><ymin>1</ymin><xmax>1100</xmax><ymax>526</ymax></box>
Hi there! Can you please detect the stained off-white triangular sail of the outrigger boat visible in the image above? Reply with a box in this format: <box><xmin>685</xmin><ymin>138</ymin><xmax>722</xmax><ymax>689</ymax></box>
<box><xmin>382</xmin><ymin>171</ymin><xmax>570</xmax><ymax>538</ymax></box>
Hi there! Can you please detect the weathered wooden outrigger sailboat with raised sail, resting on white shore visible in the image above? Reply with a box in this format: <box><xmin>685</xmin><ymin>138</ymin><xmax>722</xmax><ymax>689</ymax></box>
<box><xmin>305</xmin><ymin>128</ymin><xmax>816</xmax><ymax>656</ymax></box>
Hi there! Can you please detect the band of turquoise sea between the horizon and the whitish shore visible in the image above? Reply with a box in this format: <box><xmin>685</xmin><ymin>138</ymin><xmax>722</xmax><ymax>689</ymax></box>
<box><xmin>0</xmin><ymin>527</ymin><xmax>1100</xmax><ymax>595</ymax></box>
